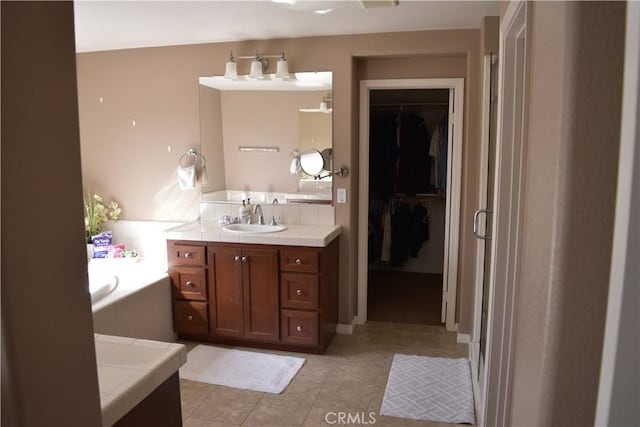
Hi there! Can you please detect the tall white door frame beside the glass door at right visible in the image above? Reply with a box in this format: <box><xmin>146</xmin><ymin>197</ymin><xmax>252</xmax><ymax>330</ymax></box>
<box><xmin>477</xmin><ymin>0</ymin><xmax>532</xmax><ymax>426</ymax></box>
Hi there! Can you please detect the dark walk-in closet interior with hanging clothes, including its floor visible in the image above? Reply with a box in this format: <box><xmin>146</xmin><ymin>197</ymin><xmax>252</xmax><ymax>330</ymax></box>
<box><xmin>367</xmin><ymin>89</ymin><xmax>450</xmax><ymax>325</ymax></box>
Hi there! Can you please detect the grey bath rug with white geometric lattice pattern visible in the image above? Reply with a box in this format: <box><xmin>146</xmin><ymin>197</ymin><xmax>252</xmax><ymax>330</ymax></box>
<box><xmin>380</xmin><ymin>354</ymin><xmax>475</xmax><ymax>424</ymax></box>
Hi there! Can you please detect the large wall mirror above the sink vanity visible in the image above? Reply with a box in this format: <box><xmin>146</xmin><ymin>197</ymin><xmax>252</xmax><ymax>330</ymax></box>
<box><xmin>200</xmin><ymin>72</ymin><xmax>333</xmax><ymax>203</ymax></box>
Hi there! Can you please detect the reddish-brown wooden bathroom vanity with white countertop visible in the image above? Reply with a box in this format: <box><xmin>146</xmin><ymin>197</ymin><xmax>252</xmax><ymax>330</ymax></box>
<box><xmin>167</xmin><ymin>225</ymin><xmax>340</xmax><ymax>353</ymax></box>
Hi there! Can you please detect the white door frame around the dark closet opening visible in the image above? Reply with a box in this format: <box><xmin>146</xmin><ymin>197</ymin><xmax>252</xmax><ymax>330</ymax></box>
<box><xmin>355</xmin><ymin>78</ymin><xmax>464</xmax><ymax>331</ymax></box>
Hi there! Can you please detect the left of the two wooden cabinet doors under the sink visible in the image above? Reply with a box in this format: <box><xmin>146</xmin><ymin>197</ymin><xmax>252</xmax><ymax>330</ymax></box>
<box><xmin>208</xmin><ymin>246</ymin><xmax>244</xmax><ymax>337</ymax></box>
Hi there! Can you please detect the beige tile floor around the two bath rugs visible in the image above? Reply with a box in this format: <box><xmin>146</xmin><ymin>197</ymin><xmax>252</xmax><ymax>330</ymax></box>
<box><xmin>180</xmin><ymin>322</ymin><xmax>468</xmax><ymax>427</ymax></box>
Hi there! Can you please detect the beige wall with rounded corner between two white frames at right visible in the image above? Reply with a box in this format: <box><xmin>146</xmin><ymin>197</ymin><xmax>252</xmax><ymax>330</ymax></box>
<box><xmin>508</xmin><ymin>2</ymin><xmax>625</xmax><ymax>426</ymax></box>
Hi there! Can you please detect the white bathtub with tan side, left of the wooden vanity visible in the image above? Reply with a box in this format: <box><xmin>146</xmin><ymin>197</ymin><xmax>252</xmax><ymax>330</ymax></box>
<box><xmin>89</xmin><ymin>259</ymin><xmax>176</xmax><ymax>342</ymax></box>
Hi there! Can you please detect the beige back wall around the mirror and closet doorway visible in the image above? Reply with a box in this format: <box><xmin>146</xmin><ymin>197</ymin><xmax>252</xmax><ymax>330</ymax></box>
<box><xmin>78</xmin><ymin>30</ymin><xmax>480</xmax><ymax>323</ymax></box>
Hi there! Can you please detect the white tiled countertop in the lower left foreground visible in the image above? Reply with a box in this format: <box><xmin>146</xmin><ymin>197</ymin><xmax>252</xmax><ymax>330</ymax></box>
<box><xmin>95</xmin><ymin>334</ymin><xmax>187</xmax><ymax>427</ymax></box>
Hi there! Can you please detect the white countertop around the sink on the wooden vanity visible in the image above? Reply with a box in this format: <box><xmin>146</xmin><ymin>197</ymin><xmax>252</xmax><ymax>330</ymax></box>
<box><xmin>166</xmin><ymin>221</ymin><xmax>342</xmax><ymax>247</ymax></box>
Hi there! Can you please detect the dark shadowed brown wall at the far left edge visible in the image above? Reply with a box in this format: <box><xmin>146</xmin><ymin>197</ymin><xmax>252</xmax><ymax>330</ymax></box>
<box><xmin>1</xmin><ymin>2</ymin><xmax>101</xmax><ymax>427</ymax></box>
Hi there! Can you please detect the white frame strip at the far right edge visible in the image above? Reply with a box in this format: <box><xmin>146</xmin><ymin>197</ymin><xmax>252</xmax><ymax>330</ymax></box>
<box><xmin>595</xmin><ymin>2</ymin><xmax>640</xmax><ymax>426</ymax></box>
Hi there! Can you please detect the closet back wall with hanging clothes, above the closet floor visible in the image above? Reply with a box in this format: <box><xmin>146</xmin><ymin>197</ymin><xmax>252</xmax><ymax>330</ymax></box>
<box><xmin>369</xmin><ymin>89</ymin><xmax>449</xmax><ymax>274</ymax></box>
